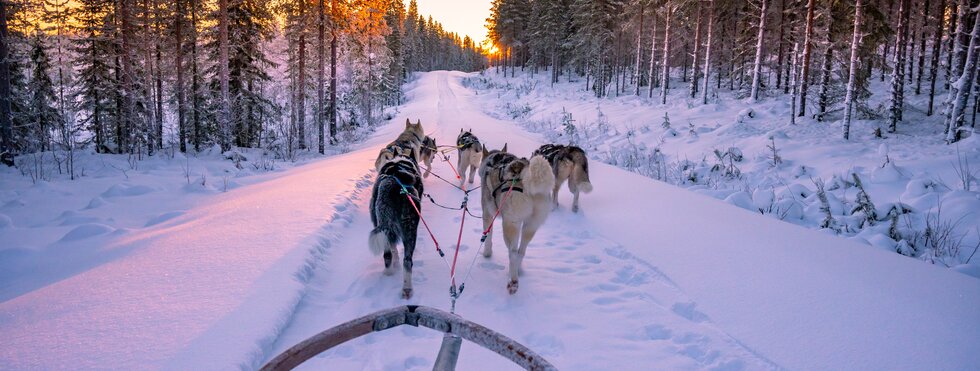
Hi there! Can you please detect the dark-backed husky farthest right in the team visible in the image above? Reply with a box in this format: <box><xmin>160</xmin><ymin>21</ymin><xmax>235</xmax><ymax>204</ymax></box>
<box><xmin>533</xmin><ymin>144</ymin><xmax>592</xmax><ymax>213</ymax></box>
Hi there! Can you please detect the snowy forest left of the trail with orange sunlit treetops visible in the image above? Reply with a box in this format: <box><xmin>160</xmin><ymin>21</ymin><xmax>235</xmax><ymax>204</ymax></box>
<box><xmin>0</xmin><ymin>0</ymin><xmax>486</xmax><ymax>164</ymax></box>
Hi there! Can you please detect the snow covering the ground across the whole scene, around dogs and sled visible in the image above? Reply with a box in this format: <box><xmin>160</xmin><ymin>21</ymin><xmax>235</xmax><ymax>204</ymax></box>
<box><xmin>0</xmin><ymin>71</ymin><xmax>980</xmax><ymax>370</ymax></box>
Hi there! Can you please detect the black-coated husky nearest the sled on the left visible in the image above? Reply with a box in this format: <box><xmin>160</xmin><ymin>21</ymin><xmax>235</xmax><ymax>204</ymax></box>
<box><xmin>368</xmin><ymin>147</ymin><xmax>423</xmax><ymax>299</ymax></box>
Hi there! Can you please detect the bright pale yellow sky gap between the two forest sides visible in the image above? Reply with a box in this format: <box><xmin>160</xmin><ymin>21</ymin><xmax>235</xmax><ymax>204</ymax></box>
<box><xmin>416</xmin><ymin>0</ymin><xmax>490</xmax><ymax>44</ymax></box>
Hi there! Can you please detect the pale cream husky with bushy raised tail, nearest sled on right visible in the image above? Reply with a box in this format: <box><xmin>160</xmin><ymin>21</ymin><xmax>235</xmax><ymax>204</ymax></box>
<box><xmin>480</xmin><ymin>144</ymin><xmax>555</xmax><ymax>294</ymax></box>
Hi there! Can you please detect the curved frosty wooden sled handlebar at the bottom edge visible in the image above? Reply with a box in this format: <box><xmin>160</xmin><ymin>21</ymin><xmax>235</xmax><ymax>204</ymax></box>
<box><xmin>262</xmin><ymin>305</ymin><xmax>557</xmax><ymax>371</ymax></box>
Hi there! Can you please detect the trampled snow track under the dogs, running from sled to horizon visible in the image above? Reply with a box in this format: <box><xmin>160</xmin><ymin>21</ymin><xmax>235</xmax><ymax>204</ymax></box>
<box><xmin>262</xmin><ymin>72</ymin><xmax>780</xmax><ymax>370</ymax></box>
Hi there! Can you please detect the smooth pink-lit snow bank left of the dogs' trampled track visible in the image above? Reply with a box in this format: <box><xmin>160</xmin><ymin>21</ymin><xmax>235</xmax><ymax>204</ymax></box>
<box><xmin>0</xmin><ymin>117</ymin><xmax>410</xmax><ymax>369</ymax></box>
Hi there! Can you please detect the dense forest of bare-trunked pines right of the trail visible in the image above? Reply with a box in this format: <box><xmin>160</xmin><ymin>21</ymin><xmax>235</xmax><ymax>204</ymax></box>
<box><xmin>487</xmin><ymin>0</ymin><xmax>980</xmax><ymax>143</ymax></box>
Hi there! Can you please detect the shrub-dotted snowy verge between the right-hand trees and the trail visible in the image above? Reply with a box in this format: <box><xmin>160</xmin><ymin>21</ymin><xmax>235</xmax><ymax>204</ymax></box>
<box><xmin>464</xmin><ymin>69</ymin><xmax>980</xmax><ymax>266</ymax></box>
